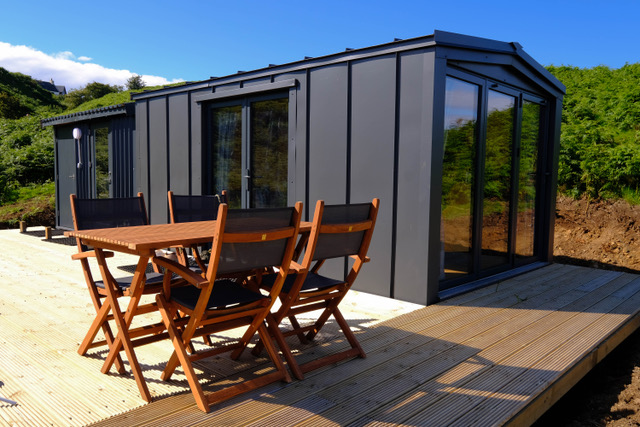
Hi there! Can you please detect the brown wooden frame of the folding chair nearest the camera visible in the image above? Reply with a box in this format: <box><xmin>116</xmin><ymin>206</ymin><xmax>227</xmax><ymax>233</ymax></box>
<box><xmin>155</xmin><ymin>202</ymin><xmax>302</xmax><ymax>412</ymax></box>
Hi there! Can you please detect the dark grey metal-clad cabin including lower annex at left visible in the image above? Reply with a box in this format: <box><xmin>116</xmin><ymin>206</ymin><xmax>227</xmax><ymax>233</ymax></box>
<box><xmin>43</xmin><ymin>31</ymin><xmax>565</xmax><ymax>304</ymax></box>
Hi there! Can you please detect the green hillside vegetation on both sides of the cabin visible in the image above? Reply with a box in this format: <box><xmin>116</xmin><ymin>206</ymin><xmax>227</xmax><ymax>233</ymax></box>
<box><xmin>0</xmin><ymin>63</ymin><xmax>640</xmax><ymax>205</ymax></box>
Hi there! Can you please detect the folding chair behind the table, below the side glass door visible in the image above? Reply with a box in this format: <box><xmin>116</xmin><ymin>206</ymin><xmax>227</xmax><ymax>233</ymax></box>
<box><xmin>167</xmin><ymin>190</ymin><xmax>227</xmax><ymax>272</ymax></box>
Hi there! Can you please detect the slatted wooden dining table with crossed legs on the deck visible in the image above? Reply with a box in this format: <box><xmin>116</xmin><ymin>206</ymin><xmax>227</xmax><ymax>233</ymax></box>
<box><xmin>64</xmin><ymin>221</ymin><xmax>311</xmax><ymax>402</ymax></box>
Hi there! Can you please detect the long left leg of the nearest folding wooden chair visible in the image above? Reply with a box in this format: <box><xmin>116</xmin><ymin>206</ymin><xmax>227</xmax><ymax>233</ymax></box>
<box><xmin>156</xmin><ymin>294</ymin><xmax>209</xmax><ymax>412</ymax></box>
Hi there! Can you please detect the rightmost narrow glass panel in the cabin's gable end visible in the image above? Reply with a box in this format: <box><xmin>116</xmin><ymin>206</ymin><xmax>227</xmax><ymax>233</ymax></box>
<box><xmin>515</xmin><ymin>101</ymin><xmax>541</xmax><ymax>257</ymax></box>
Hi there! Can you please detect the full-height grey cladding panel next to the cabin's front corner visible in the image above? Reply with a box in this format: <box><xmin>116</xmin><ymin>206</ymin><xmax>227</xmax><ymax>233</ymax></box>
<box><xmin>394</xmin><ymin>49</ymin><xmax>439</xmax><ymax>303</ymax></box>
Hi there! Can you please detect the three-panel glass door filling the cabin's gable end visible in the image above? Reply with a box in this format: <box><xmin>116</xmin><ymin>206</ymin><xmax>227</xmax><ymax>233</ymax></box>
<box><xmin>440</xmin><ymin>76</ymin><xmax>544</xmax><ymax>289</ymax></box>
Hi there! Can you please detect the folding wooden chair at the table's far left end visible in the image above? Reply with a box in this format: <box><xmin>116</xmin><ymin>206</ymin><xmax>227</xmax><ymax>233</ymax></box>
<box><xmin>70</xmin><ymin>193</ymin><xmax>164</xmax><ymax>374</ymax></box>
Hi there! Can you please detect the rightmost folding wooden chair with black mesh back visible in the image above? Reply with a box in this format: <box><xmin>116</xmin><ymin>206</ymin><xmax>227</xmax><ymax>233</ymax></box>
<box><xmin>253</xmin><ymin>199</ymin><xmax>380</xmax><ymax>379</ymax></box>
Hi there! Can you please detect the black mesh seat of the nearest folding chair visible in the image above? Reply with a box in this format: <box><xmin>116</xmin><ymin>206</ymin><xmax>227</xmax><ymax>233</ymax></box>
<box><xmin>171</xmin><ymin>279</ymin><xmax>267</xmax><ymax>310</ymax></box>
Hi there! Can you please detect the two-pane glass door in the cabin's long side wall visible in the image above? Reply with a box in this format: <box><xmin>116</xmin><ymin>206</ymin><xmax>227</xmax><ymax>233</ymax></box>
<box><xmin>204</xmin><ymin>96</ymin><xmax>289</xmax><ymax>208</ymax></box>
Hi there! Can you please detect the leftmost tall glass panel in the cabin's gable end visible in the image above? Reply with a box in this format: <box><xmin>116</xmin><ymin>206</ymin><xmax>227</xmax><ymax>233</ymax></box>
<box><xmin>441</xmin><ymin>77</ymin><xmax>479</xmax><ymax>279</ymax></box>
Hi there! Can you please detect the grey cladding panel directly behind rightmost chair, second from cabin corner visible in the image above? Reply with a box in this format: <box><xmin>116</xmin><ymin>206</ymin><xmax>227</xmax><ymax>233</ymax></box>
<box><xmin>349</xmin><ymin>54</ymin><xmax>398</xmax><ymax>295</ymax></box>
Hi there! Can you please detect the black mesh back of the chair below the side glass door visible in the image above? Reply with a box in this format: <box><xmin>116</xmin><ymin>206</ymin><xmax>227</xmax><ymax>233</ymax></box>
<box><xmin>169</xmin><ymin>191</ymin><xmax>227</xmax><ymax>223</ymax></box>
